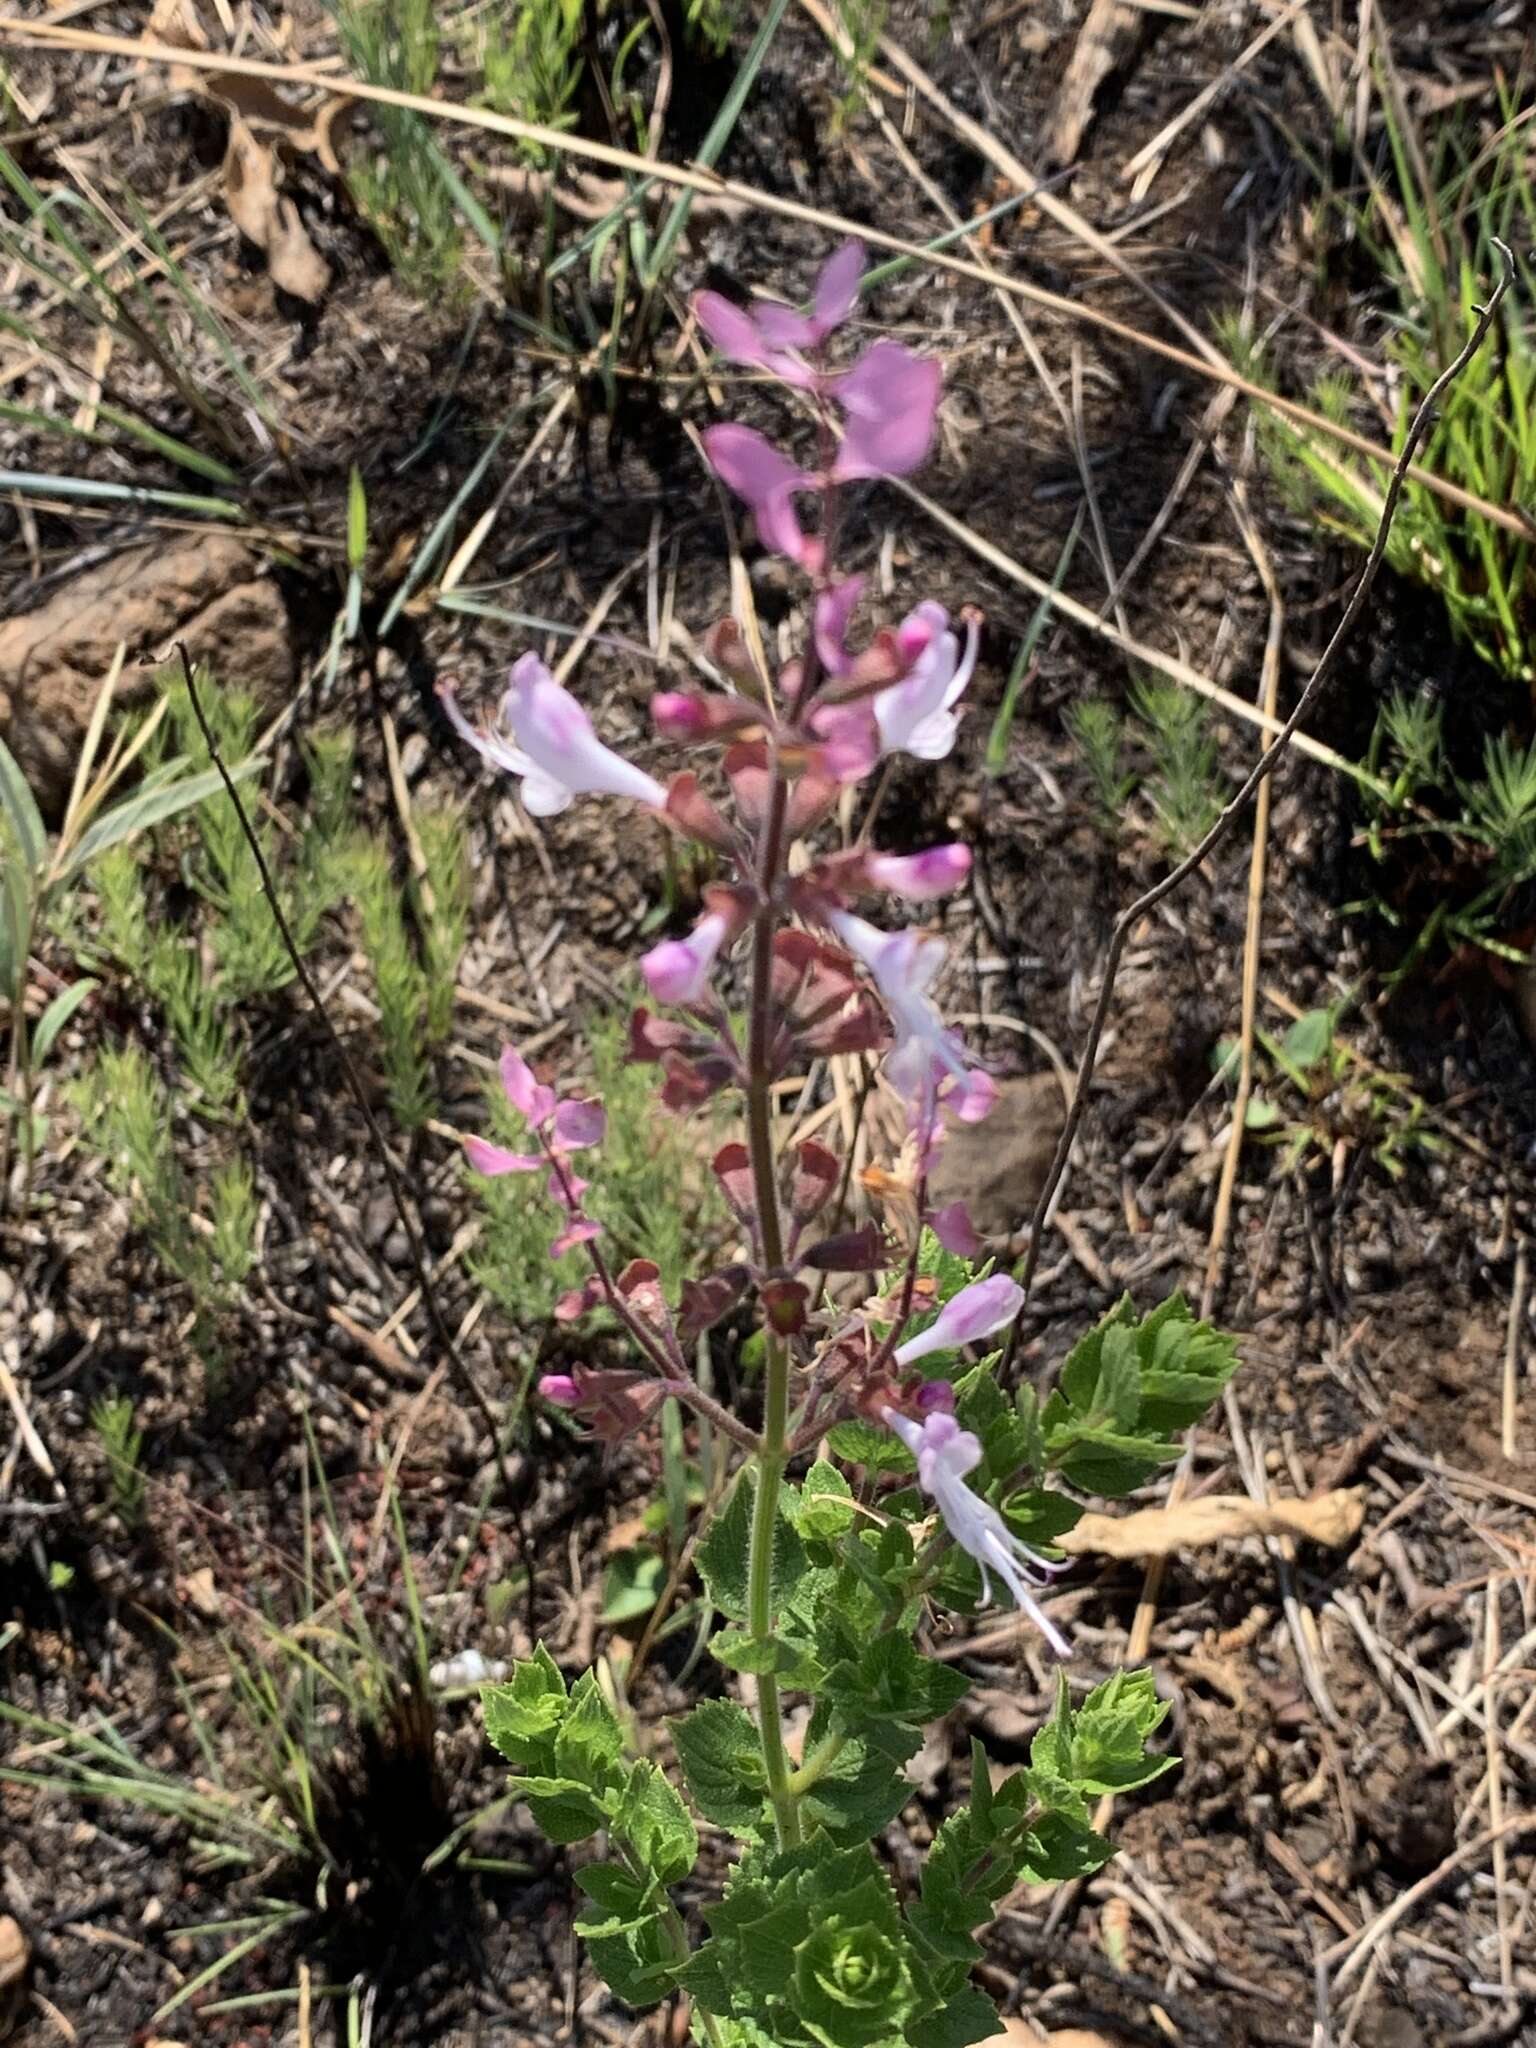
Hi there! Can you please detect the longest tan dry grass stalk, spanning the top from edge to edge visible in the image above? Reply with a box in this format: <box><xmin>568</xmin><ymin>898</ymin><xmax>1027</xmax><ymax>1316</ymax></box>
<box><xmin>0</xmin><ymin>16</ymin><xmax>1528</xmax><ymax>539</ymax></box>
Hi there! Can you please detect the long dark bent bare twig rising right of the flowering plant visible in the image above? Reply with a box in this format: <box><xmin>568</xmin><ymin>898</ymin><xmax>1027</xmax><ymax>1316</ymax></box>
<box><xmin>1004</xmin><ymin>238</ymin><xmax>1516</xmax><ymax>1372</ymax></box>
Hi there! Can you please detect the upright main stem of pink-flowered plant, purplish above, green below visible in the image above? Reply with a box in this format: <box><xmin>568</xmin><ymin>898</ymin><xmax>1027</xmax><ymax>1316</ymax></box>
<box><xmin>748</xmin><ymin>762</ymin><xmax>801</xmax><ymax>1849</ymax></box>
